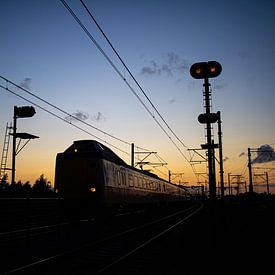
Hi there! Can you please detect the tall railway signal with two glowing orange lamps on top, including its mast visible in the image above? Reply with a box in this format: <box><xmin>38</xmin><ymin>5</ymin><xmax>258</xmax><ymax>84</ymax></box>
<box><xmin>190</xmin><ymin>61</ymin><xmax>222</xmax><ymax>199</ymax></box>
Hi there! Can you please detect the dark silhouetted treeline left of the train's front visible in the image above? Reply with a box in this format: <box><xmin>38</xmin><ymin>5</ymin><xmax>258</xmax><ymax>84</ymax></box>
<box><xmin>0</xmin><ymin>174</ymin><xmax>57</xmax><ymax>198</ymax></box>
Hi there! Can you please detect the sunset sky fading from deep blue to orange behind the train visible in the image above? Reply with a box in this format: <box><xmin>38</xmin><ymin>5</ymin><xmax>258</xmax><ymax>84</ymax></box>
<box><xmin>0</xmin><ymin>0</ymin><xmax>275</xmax><ymax>194</ymax></box>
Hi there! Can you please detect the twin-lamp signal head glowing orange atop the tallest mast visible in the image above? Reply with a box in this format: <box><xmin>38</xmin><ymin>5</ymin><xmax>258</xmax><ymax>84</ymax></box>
<box><xmin>190</xmin><ymin>61</ymin><xmax>222</xmax><ymax>79</ymax></box>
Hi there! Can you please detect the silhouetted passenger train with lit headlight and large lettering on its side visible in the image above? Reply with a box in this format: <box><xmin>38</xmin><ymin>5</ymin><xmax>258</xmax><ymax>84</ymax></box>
<box><xmin>54</xmin><ymin>140</ymin><xmax>192</xmax><ymax>210</ymax></box>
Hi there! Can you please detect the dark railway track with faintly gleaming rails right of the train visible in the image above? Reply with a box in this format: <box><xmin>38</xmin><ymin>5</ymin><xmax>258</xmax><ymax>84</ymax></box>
<box><xmin>2</xmin><ymin>203</ymin><xmax>203</xmax><ymax>274</ymax></box>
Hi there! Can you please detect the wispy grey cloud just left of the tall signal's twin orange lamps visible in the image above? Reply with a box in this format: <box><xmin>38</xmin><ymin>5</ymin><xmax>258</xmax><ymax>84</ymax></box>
<box><xmin>140</xmin><ymin>52</ymin><xmax>188</xmax><ymax>77</ymax></box>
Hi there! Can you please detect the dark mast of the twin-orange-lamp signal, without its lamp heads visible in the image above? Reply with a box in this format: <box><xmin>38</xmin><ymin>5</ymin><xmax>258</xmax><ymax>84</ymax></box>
<box><xmin>204</xmin><ymin>77</ymin><xmax>216</xmax><ymax>199</ymax></box>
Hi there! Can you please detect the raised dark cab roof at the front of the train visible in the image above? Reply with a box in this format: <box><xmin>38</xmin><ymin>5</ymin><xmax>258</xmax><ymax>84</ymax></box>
<box><xmin>61</xmin><ymin>140</ymin><xmax>127</xmax><ymax>165</ymax></box>
